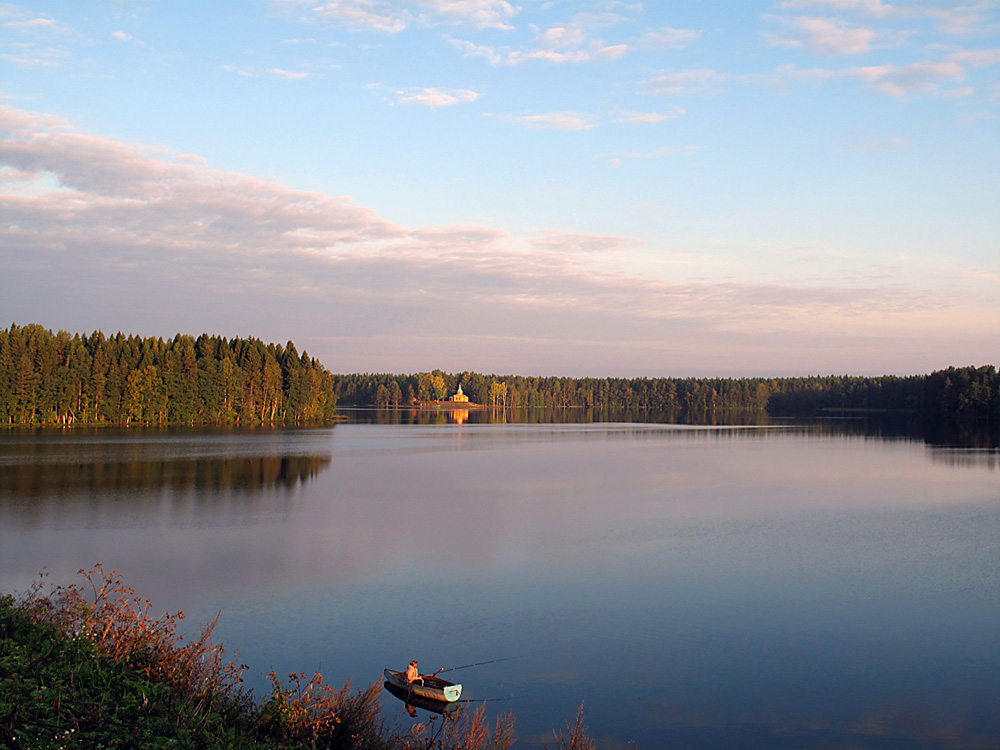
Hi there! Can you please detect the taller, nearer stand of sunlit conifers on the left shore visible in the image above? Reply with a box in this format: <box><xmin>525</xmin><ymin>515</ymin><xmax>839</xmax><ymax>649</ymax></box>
<box><xmin>0</xmin><ymin>324</ymin><xmax>337</xmax><ymax>426</ymax></box>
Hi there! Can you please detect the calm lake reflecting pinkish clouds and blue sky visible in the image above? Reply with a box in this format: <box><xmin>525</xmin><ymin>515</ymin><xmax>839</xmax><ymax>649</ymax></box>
<box><xmin>0</xmin><ymin>420</ymin><xmax>1000</xmax><ymax>750</ymax></box>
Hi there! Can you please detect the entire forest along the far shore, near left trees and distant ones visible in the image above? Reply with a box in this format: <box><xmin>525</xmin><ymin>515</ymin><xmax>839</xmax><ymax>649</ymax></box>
<box><xmin>0</xmin><ymin>324</ymin><xmax>1000</xmax><ymax>426</ymax></box>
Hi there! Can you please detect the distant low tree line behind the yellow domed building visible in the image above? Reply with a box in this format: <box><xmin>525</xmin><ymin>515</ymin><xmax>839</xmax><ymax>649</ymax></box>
<box><xmin>333</xmin><ymin>365</ymin><xmax>1000</xmax><ymax>424</ymax></box>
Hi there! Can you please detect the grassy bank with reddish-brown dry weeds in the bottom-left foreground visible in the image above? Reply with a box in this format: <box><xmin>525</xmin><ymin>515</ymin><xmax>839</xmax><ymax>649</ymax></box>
<box><xmin>0</xmin><ymin>565</ymin><xmax>595</xmax><ymax>750</ymax></box>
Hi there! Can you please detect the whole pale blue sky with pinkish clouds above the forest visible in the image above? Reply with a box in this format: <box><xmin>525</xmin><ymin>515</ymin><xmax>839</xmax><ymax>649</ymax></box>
<box><xmin>0</xmin><ymin>0</ymin><xmax>1000</xmax><ymax>377</ymax></box>
